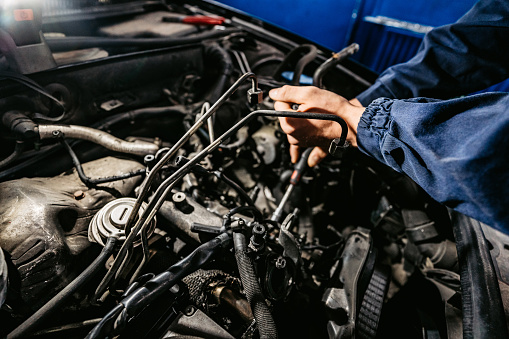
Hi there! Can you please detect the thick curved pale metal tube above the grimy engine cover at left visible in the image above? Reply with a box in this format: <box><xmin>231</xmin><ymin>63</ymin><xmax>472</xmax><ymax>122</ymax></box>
<box><xmin>39</xmin><ymin>125</ymin><xmax>159</xmax><ymax>155</ymax></box>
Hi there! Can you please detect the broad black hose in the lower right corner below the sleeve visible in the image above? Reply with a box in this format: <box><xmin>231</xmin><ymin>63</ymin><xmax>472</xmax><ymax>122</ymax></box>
<box><xmin>451</xmin><ymin>211</ymin><xmax>509</xmax><ymax>339</ymax></box>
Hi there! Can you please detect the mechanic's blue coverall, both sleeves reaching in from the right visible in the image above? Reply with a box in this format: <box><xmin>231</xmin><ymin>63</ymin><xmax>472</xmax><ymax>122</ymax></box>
<box><xmin>357</xmin><ymin>0</ymin><xmax>509</xmax><ymax>234</ymax></box>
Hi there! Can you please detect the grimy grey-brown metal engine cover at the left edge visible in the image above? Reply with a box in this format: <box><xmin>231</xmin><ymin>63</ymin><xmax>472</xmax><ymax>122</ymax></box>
<box><xmin>0</xmin><ymin>157</ymin><xmax>143</xmax><ymax>308</ymax></box>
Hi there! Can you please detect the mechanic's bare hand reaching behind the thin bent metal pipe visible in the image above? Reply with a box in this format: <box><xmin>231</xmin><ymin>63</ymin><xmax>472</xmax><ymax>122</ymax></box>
<box><xmin>269</xmin><ymin>86</ymin><xmax>364</xmax><ymax>167</ymax></box>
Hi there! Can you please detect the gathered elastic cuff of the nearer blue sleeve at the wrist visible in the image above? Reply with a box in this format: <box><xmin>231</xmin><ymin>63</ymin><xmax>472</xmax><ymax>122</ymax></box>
<box><xmin>357</xmin><ymin>98</ymin><xmax>394</xmax><ymax>163</ymax></box>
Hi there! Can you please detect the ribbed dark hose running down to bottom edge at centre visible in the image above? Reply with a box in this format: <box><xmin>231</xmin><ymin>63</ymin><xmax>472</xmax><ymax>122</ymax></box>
<box><xmin>233</xmin><ymin>232</ymin><xmax>277</xmax><ymax>339</ymax></box>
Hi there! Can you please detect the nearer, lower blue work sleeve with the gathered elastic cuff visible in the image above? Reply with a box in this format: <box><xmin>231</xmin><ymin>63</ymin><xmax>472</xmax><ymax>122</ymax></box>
<box><xmin>357</xmin><ymin>93</ymin><xmax>509</xmax><ymax>233</ymax></box>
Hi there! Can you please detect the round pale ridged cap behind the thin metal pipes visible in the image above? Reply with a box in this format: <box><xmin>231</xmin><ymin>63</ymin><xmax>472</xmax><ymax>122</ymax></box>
<box><xmin>88</xmin><ymin>198</ymin><xmax>156</xmax><ymax>246</ymax></box>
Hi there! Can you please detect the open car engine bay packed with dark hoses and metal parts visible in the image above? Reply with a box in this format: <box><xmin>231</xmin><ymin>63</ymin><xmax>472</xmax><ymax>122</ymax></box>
<box><xmin>0</xmin><ymin>1</ymin><xmax>509</xmax><ymax>338</ymax></box>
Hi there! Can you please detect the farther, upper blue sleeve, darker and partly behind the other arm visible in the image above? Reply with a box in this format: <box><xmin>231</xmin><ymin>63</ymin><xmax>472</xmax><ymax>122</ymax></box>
<box><xmin>357</xmin><ymin>0</ymin><xmax>509</xmax><ymax>106</ymax></box>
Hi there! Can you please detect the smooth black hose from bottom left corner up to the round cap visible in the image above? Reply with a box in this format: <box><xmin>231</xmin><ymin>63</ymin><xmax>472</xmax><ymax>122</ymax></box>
<box><xmin>7</xmin><ymin>237</ymin><xmax>117</xmax><ymax>339</ymax></box>
